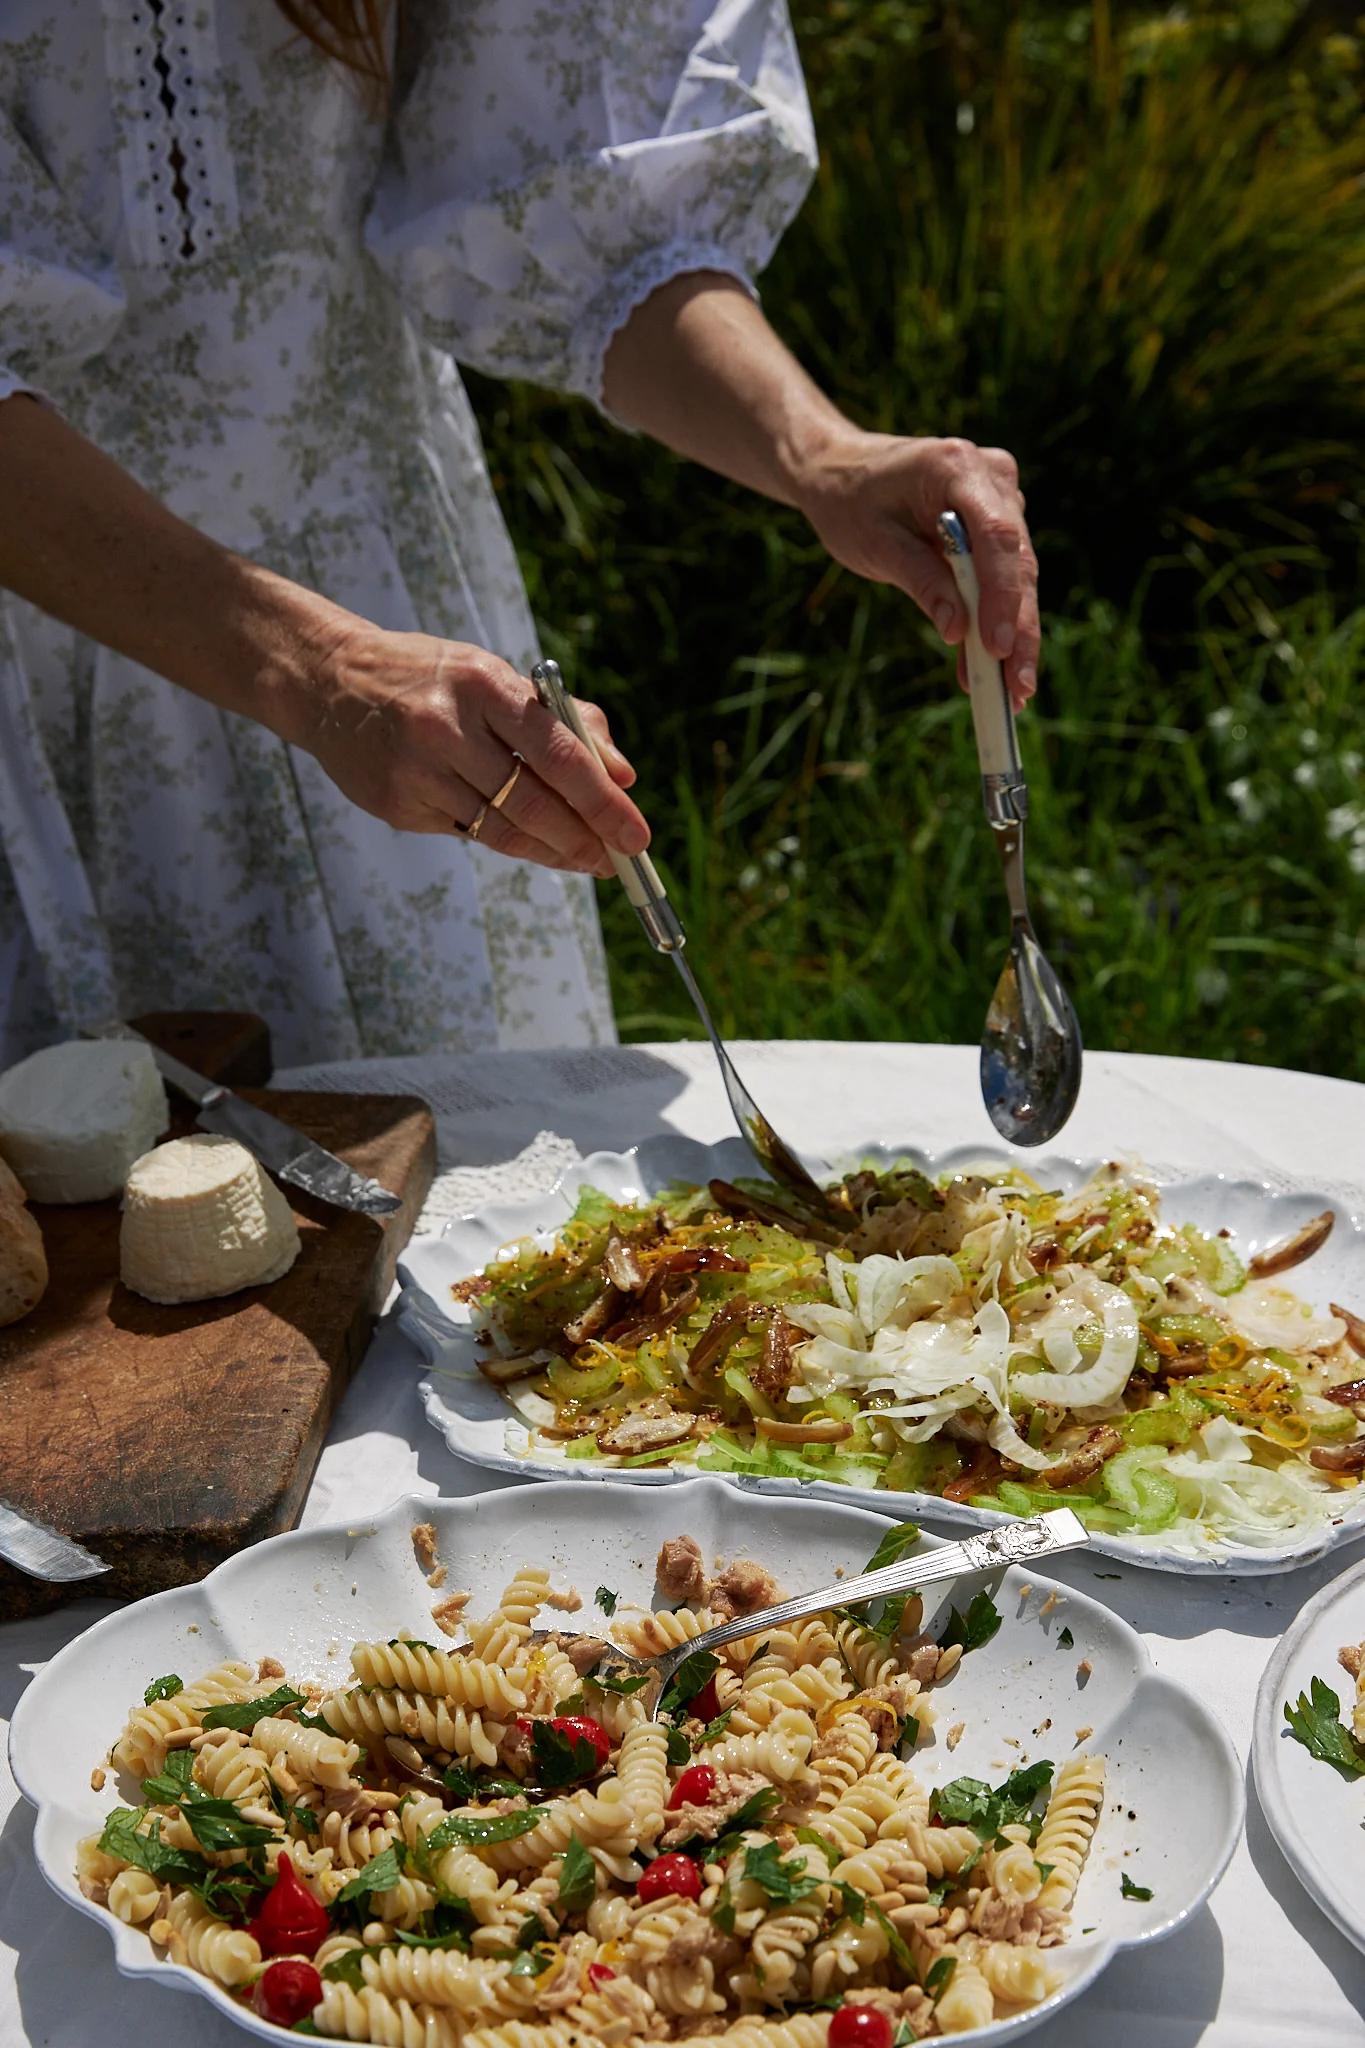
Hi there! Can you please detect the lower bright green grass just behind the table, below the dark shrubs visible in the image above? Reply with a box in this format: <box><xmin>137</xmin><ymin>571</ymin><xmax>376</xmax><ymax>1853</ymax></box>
<box><xmin>602</xmin><ymin>604</ymin><xmax>1365</xmax><ymax>1079</ymax></box>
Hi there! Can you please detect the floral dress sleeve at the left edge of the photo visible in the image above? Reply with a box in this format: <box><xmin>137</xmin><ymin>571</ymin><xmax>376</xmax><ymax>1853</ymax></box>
<box><xmin>0</xmin><ymin>111</ymin><xmax>123</xmax><ymax>399</ymax></box>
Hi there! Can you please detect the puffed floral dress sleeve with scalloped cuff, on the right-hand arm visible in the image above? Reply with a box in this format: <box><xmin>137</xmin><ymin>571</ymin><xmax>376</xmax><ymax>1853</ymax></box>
<box><xmin>368</xmin><ymin>0</ymin><xmax>817</xmax><ymax>403</ymax></box>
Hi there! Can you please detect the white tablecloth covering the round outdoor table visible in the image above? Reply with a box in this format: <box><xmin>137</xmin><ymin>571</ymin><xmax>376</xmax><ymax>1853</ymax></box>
<box><xmin>0</xmin><ymin>1042</ymin><xmax>1365</xmax><ymax>2048</ymax></box>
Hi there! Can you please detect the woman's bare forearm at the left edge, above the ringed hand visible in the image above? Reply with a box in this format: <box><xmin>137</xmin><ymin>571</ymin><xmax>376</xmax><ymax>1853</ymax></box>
<box><xmin>0</xmin><ymin>397</ymin><xmax>341</xmax><ymax>739</ymax></box>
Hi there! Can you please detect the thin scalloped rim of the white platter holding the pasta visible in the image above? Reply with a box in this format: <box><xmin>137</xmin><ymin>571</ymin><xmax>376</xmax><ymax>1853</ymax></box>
<box><xmin>6</xmin><ymin>1473</ymin><xmax>1246</xmax><ymax>2042</ymax></box>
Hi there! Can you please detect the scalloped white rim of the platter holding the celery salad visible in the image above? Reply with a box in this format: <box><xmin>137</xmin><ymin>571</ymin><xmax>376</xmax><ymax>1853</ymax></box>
<box><xmin>395</xmin><ymin>1130</ymin><xmax>1365</xmax><ymax>1579</ymax></box>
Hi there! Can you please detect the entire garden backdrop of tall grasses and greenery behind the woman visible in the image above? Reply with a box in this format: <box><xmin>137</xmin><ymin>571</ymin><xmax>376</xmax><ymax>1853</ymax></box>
<box><xmin>475</xmin><ymin>0</ymin><xmax>1365</xmax><ymax>1079</ymax></box>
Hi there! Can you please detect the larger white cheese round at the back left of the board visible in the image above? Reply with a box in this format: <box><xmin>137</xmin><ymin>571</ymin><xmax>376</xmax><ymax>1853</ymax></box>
<box><xmin>0</xmin><ymin>1038</ymin><xmax>170</xmax><ymax>1202</ymax></box>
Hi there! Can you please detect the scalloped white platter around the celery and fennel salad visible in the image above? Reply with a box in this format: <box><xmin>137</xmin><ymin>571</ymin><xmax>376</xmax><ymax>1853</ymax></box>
<box><xmin>397</xmin><ymin>1135</ymin><xmax>1365</xmax><ymax>1575</ymax></box>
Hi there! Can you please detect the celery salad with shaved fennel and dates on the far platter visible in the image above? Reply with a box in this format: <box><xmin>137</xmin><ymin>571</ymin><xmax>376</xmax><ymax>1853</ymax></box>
<box><xmin>456</xmin><ymin>1165</ymin><xmax>1365</xmax><ymax>1556</ymax></box>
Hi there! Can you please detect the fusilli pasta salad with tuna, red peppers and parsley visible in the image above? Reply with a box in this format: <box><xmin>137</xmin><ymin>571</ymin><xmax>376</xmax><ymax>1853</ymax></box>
<box><xmin>78</xmin><ymin>1528</ymin><xmax>1113</xmax><ymax>2048</ymax></box>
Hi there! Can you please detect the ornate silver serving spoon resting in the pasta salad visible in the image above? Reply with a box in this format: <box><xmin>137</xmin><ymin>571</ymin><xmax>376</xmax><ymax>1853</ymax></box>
<box><xmin>389</xmin><ymin>1507</ymin><xmax>1091</xmax><ymax>1792</ymax></box>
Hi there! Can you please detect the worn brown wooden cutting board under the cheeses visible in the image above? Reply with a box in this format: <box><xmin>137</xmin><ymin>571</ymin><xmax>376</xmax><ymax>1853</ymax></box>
<box><xmin>0</xmin><ymin>1014</ymin><xmax>436</xmax><ymax>1620</ymax></box>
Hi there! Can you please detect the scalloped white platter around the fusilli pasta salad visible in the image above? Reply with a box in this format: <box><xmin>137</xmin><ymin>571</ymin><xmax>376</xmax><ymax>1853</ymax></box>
<box><xmin>10</xmin><ymin>1479</ymin><xmax>1244</xmax><ymax>2042</ymax></box>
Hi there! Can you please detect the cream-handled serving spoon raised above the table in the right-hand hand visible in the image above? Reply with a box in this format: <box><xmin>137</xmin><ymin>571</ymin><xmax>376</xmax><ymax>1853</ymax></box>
<box><xmin>939</xmin><ymin>512</ymin><xmax>1081</xmax><ymax>1145</ymax></box>
